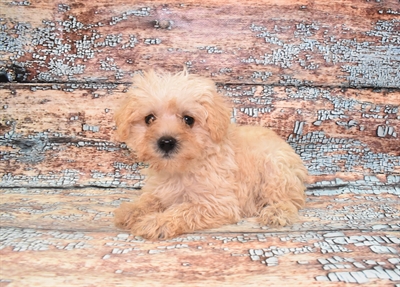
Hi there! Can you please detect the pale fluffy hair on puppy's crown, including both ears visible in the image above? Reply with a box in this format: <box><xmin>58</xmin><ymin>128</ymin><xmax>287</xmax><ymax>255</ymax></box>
<box><xmin>115</xmin><ymin>69</ymin><xmax>231</xmax><ymax>142</ymax></box>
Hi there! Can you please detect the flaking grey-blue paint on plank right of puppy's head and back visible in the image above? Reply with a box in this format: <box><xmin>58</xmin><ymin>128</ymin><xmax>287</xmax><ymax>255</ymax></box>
<box><xmin>222</xmin><ymin>85</ymin><xmax>400</xmax><ymax>184</ymax></box>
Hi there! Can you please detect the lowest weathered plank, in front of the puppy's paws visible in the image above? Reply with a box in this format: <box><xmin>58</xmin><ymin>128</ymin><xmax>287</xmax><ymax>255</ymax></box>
<box><xmin>0</xmin><ymin>228</ymin><xmax>400</xmax><ymax>287</ymax></box>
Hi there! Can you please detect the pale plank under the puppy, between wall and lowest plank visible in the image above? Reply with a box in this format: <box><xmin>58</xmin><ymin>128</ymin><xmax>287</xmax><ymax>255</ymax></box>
<box><xmin>0</xmin><ymin>188</ymin><xmax>400</xmax><ymax>232</ymax></box>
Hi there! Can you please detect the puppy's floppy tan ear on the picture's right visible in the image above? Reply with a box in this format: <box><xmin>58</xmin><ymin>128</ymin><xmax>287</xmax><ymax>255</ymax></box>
<box><xmin>203</xmin><ymin>91</ymin><xmax>231</xmax><ymax>142</ymax></box>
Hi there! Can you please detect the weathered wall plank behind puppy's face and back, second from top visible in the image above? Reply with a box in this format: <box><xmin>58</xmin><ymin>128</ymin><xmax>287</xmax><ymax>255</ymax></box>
<box><xmin>0</xmin><ymin>84</ymin><xmax>400</xmax><ymax>187</ymax></box>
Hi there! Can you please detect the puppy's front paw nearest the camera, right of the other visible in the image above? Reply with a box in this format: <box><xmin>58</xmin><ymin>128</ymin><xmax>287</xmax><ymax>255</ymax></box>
<box><xmin>131</xmin><ymin>213</ymin><xmax>183</xmax><ymax>240</ymax></box>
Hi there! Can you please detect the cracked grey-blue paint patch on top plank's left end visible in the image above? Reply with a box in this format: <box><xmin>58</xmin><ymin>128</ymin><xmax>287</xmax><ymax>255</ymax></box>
<box><xmin>0</xmin><ymin>4</ymin><xmax>150</xmax><ymax>82</ymax></box>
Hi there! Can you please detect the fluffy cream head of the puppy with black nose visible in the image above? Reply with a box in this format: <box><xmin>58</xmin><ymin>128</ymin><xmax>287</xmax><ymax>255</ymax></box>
<box><xmin>115</xmin><ymin>71</ymin><xmax>230</xmax><ymax>171</ymax></box>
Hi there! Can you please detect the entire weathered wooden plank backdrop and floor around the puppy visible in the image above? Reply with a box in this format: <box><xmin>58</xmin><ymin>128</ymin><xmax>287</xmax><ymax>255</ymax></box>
<box><xmin>0</xmin><ymin>0</ymin><xmax>400</xmax><ymax>286</ymax></box>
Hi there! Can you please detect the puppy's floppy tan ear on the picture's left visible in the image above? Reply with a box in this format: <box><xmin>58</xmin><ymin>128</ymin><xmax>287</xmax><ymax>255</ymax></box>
<box><xmin>114</xmin><ymin>96</ymin><xmax>138</xmax><ymax>142</ymax></box>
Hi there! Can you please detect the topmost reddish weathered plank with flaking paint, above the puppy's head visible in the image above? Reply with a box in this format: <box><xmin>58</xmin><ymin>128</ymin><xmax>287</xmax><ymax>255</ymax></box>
<box><xmin>0</xmin><ymin>0</ymin><xmax>400</xmax><ymax>88</ymax></box>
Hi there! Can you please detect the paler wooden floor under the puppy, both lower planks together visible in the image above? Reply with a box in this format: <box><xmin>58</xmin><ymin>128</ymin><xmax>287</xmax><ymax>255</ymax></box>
<box><xmin>0</xmin><ymin>188</ymin><xmax>400</xmax><ymax>287</ymax></box>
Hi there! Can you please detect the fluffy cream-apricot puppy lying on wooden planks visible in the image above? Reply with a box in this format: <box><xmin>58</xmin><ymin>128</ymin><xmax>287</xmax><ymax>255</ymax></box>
<box><xmin>114</xmin><ymin>71</ymin><xmax>307</xmax><ymax>239</ymax></box>
